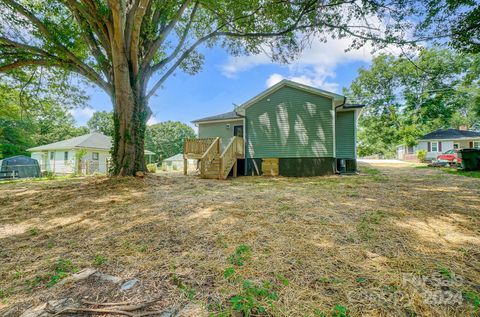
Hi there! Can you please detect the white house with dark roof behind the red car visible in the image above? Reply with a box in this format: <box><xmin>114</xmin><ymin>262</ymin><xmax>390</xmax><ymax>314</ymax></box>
<box><xmin>397</xmin><ymin>128</ymin><xmax>480</xmax><ymax>160</ymax></box>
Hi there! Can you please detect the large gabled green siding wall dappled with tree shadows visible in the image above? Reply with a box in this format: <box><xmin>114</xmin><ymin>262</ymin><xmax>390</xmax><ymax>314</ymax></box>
<box><xmin>245</xmin><ymin>86</ymin><xmax>335</xmax><ymax>158</ymax></box>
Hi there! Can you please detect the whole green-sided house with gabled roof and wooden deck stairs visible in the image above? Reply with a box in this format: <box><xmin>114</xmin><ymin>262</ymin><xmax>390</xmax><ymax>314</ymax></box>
<box><xmin>184</xmin><ymin>80</ymin><xmax>363</xmax><ymax>178</ymax></box>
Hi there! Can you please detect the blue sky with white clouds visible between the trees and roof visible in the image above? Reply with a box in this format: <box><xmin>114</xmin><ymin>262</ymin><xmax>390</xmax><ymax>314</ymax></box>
<box><xmin>72</xmin><ymin>39</ymin><xmax>378</xmax><ymax>125</ymax></box>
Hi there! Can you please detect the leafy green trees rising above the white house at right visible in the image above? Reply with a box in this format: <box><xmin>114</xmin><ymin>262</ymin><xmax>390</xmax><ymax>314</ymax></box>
<box><xmin>345</xmin><ymin>48</ymin><xmax>480</xmax><ymax>156</ymax></box>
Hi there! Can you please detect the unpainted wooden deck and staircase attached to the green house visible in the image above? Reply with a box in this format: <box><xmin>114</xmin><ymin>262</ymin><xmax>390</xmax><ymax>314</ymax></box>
<box><xmin>184</xmin><ymin>136</ymin><xmax>244</xmax><ymax>179</ymax></box>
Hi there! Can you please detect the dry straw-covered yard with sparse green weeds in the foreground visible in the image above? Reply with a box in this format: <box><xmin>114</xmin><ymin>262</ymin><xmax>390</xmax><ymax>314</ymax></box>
<box><xmin>0</xmin><ymin>164</ymin><xmax>480</xmax><ymax>316</ymax></box>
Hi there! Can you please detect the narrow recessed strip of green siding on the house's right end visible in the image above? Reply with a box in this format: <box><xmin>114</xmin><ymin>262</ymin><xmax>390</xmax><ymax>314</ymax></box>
<box><xmin>335</xmin><ymin>111</ymin><xmax>355</xmax><ymax>159</ymax></box>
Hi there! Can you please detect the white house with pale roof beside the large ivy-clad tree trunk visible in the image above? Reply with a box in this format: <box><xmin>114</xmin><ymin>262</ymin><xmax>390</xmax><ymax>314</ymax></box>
<box><xmin>28</xmin><ymin>132</ymin><xmax>155</xmax><ymax>174</ymax></box>
